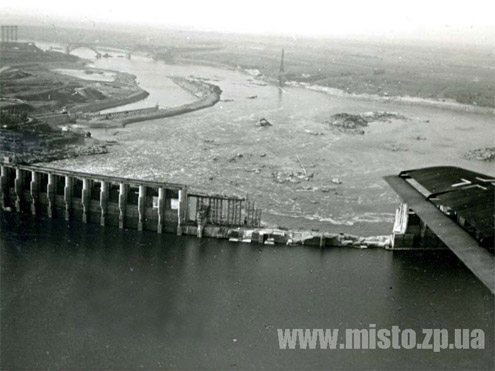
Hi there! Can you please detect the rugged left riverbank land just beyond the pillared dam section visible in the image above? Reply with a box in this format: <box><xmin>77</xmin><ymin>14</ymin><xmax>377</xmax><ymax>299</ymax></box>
<box><xmin>0</xmin><ymin>42</ymin><xmax>148</xmax><ymax>164</ymax></box>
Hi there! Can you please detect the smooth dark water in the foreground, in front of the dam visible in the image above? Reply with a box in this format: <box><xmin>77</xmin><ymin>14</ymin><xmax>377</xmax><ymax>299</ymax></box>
<box><xmin>0</xmin><ymin>213</ymin><xmax>494</xmax><ymax>370</ymax></box>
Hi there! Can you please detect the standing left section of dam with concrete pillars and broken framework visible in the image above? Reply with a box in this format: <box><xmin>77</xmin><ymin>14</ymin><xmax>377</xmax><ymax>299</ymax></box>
<box><xmin>0</xmin><ymin>163</ymin><xmax>261</xmax><ymax>237</ymax></box>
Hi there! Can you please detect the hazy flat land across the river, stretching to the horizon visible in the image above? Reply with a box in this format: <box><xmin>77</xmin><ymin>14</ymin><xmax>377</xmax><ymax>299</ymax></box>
<box><xmin>17</xmin><ymin>24</ymin><xmax>495</xmax><ymax>108</ymax></box>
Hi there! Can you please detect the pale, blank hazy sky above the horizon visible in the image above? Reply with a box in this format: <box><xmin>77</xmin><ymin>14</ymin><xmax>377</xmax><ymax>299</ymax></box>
<box><xmin>0</xmin><ymin>0</ymin><xmax>495</xmax><ymax>44</ymax></box>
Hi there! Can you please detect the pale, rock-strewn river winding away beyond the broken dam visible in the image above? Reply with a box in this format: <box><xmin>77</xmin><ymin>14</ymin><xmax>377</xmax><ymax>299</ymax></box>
<box><xmin>38</xmin><ymin>42</ymin><xmax>495</xmax><ymax>235</ymax></box>
